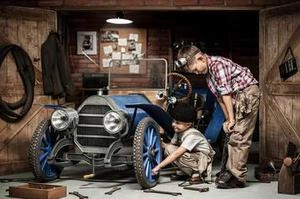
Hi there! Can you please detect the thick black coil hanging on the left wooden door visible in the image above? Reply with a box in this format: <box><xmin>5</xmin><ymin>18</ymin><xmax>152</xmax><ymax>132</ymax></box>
<box><xmin>0</xmin><ymin>44</ymin><xmax>35</xmax><ymax>122</ymax></box>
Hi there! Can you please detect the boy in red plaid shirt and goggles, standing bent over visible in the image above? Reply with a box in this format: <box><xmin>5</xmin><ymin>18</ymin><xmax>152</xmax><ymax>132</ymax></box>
<box><xmin>175</xmin><ymin>45</ymin><xmax>260</xmax><ymax>188</ymax></box>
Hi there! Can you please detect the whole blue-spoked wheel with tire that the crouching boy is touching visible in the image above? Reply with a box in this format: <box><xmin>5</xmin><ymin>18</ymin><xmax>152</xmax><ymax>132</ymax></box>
<box><xmin>133</xmin><ymin>117</ymin><xmax>162</xmax><ymax>188</ymax></box>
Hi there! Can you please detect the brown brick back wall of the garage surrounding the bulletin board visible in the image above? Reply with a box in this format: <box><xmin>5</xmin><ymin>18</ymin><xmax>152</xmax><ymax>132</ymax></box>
<box><xmin>59</xmin><ymin>11</ymin><xmax>172</xmax><ymax>105</ymax></box>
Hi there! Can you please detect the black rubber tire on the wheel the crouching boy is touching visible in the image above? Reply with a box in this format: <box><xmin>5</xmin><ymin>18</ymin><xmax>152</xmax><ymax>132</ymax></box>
<box><xmin>133</xmin><ymin>117</ymin><xmax>162</xmax><ymax>189</ymax></box>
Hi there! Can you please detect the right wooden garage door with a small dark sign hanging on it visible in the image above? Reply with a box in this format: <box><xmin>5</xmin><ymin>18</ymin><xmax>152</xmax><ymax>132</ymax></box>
<box><xmin>259</xmin><ymin>2</ymin><xmax>300</xmax><ymax>166</ymax></box>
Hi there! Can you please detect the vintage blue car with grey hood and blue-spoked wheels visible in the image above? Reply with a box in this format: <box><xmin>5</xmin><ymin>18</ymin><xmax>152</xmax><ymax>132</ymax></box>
<box><xmin>29</xmin><ymin>59</ymin><xmax>225</xmax><ymax>188</ymax></box>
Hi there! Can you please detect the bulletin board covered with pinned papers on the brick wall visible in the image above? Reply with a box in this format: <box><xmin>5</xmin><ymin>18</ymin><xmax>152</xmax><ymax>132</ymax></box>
<box><xmin>99</xmin><ymin>28</ymin><xmax>147</xmax><ymax>74</ymax></box>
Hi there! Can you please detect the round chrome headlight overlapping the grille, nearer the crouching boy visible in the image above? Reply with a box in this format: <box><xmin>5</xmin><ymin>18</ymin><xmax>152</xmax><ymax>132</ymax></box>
<box><xmin>103</xmin><ymin>111</ymin><xmax>127</xmax><ymax>135</ymax></box>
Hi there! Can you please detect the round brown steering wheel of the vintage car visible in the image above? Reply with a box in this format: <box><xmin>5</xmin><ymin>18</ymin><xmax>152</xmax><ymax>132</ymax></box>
<box><xmin>168</xmin><ymin>73</ymin><xmax>192</xmax><ymax>102</ymax></box>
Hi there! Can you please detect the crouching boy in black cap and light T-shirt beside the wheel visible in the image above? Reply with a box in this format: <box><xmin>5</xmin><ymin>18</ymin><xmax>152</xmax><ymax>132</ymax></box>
<box><xmin>152</xmin><ymin>103</ymin><xmax>215</xmax><ymax>184</ymax></box>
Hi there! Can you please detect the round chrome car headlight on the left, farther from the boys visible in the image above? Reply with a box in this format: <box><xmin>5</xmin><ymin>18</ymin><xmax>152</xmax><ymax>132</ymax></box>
<box><xmin>51</xmin><ymin>108</ymin><xmax>79</xmax><ymax>131</ymax></box>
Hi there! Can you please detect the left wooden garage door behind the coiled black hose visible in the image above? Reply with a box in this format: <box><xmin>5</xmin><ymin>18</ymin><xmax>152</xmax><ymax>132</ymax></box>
<box><xmin>0</xmin><ymin>7</ymin><xmax>57</xmax><ymax>175</ymax></box>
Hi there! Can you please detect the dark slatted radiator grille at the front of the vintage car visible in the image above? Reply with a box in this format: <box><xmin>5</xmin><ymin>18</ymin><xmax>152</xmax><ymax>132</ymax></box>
<box><xmin>76</xmin><ymin>105</ymin><xmax>116</xmax><ymax>147</ymax></box>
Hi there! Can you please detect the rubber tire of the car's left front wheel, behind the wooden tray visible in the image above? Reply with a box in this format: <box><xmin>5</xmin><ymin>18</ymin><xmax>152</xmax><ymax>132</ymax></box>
<box><xmin>28</xmin><ymin>118</ymin><xmax>62</xmax><ymax>182</ymax></box>
